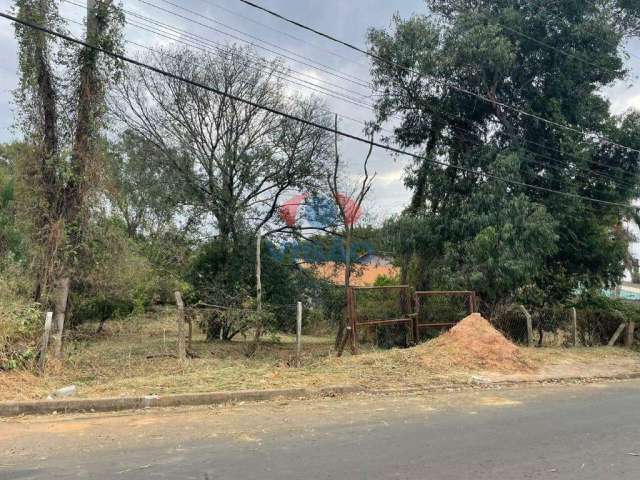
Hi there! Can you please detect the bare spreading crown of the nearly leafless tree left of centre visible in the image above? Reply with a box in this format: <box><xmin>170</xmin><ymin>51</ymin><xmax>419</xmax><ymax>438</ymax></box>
<box><xmin>113</xmin><ymin>47</ymin><xmax>330</xmax><ymax>248</ymax></box>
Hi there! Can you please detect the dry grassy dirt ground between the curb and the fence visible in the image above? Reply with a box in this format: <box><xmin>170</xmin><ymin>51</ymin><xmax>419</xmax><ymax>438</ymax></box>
<box><xmin>0</xmin><ymin>313</ymin><xmax>640</xmax><ymax>401</ymax></box>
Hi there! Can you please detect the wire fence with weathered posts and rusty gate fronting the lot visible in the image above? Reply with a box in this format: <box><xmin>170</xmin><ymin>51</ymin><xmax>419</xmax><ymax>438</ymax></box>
<box><xmin>57</xmin><ymin>288</ymin><xmax>640</xmax><ymax>369</ymax></box>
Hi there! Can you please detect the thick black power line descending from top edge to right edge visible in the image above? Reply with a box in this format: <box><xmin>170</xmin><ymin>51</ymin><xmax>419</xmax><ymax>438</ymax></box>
<box><xmin>239</xmin><ymin>0</ymin><xmax>640</xmax><ymax>153</ymax></box>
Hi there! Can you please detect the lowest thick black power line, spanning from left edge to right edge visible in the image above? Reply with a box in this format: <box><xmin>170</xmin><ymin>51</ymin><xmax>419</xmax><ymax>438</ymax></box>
<box><xmin>0</xmin><ymin>12</ymin><xmax>640</xmax><ymax>210</ymax></box>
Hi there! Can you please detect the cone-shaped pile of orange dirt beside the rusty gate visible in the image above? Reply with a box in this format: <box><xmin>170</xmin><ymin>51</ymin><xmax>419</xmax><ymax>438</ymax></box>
<box><xmin>416</xmin><ymin>313</ymin><xmax>533</xmax><ymax>372</ymax></box>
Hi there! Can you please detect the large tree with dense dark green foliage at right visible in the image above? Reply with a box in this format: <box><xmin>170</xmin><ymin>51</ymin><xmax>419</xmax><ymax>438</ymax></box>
<box><xmin>369</xmin><ymin>0</ymin><xmax>640</xmax><ymax>312</ymax></box>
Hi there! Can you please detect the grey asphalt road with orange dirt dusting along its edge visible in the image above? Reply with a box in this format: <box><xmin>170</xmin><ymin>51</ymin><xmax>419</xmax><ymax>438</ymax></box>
<box><xmin>0</xmin><ymin>381</ymin><xmax>640</xmax><ymax>480</ymax></box>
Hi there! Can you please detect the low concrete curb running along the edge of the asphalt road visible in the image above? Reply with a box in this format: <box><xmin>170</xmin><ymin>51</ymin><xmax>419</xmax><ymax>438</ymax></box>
<box><xmin>0</xmin><ymin>372</ymin><xmax>640</xmax><ymax>417</ymax></box>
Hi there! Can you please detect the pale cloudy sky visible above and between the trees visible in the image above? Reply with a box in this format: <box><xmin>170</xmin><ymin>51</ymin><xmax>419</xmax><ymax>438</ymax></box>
<box><xmin>0</xmin><ymin>0</ymin><xmax>640</xmax><ymax>219</ymax></box>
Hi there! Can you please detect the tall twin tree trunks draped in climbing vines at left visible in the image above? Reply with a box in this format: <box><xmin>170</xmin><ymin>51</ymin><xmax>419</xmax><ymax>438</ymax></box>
<box><xmin>16</xmin><ymin>0</ymin><xmax>124</xmax><ymax>352</ymax></box>
